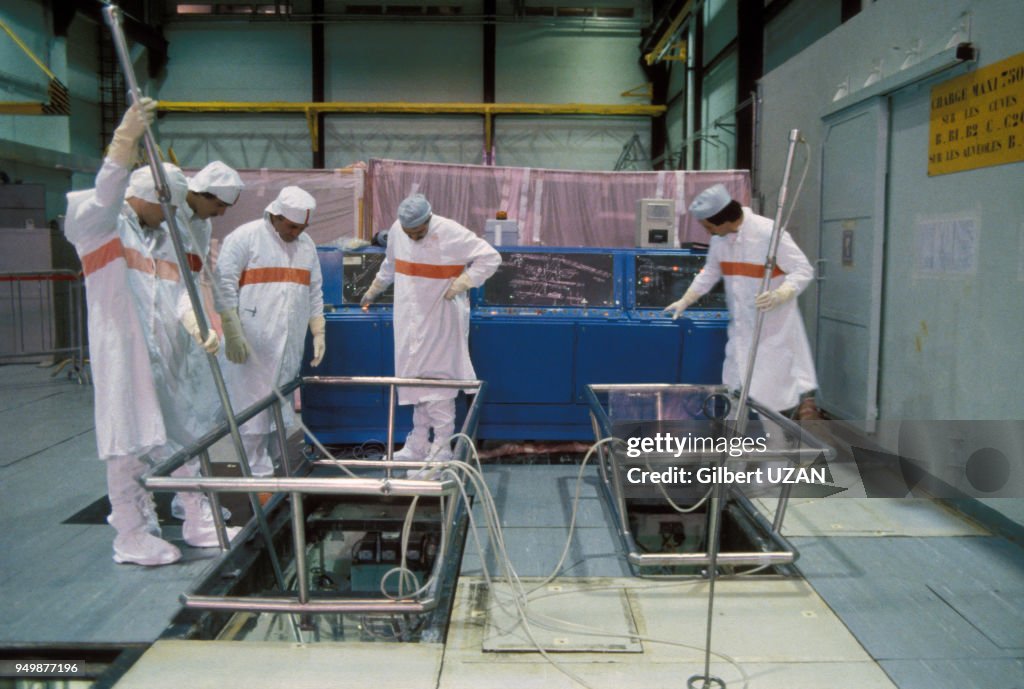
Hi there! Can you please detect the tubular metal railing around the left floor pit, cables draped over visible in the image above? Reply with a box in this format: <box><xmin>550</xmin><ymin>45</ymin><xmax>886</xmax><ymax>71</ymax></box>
<box><xmin>142</xmin><ymin>377</ymin><xmax>486</xmax><ymax>614</ymax></box>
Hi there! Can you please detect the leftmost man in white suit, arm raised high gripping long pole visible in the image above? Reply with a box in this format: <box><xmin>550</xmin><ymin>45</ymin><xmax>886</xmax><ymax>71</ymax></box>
<box><xmin>65</xmin><ymin>98</ymin><xmax>237</xmax><ymax>566</ymax></box>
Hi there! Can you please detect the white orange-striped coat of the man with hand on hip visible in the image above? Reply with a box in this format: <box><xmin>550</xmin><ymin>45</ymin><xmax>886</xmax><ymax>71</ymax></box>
<box><xmin>377</xmin><ymin>215</ymin><xmax>502</xmax><ymax>404</ymax></box>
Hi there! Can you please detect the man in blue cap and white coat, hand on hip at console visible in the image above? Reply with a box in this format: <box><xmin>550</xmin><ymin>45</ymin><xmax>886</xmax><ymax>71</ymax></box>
<box><xmin>361</xmin><ymin>193</ymin><xmax>502</xmax><ymax>464</ymax></box>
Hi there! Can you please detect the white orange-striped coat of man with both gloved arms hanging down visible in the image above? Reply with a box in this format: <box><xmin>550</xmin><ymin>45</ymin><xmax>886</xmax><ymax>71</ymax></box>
<box><xmin>217</xmin><ymin>213</ymin><xmax>324</xmax><ymax>435</ymax></box>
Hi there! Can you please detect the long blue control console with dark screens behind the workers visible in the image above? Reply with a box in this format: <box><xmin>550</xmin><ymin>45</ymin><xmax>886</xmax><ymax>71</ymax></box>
<box><xmin>302</xmin><ymin>247</ymin><xmax>728</xmax><ymax>443</ymax></box>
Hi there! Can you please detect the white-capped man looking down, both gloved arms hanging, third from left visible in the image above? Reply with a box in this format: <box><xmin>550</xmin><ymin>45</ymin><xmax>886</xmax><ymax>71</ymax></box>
<box><xmin>216</xmin><ymin>186</ymin><xmax>327</xmax><ymax>476</ymax></box>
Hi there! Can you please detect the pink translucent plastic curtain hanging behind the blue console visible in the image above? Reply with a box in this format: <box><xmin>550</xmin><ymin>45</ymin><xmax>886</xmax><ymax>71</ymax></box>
<box><xmin>192</xmin><ymin>159</ymin><xmax>751</xmax><ymax>247</ymax></box>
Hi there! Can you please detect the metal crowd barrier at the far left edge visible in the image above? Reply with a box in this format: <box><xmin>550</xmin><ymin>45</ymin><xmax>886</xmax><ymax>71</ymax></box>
<box><xmin>0</xmin><ymin>269</ymin><xmax>88</xmax><ymax>383</ymax></box>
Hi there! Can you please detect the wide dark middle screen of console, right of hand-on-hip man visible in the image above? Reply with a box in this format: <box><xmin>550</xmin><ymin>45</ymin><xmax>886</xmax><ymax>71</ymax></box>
<box><xmin>481</xmin><ymin>251</ymin><xmax>615</xmax><ymax>308</ymax></box>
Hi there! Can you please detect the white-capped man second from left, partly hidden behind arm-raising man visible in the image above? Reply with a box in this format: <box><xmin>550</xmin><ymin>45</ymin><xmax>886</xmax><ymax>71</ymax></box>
<box><xmin>167</xmin><ymin>161</ymin><xmax>245</xmax><ymax>520</ymax></box>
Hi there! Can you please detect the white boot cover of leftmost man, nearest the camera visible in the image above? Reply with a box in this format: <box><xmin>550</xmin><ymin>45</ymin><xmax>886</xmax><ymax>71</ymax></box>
<box><xmin>106</xmin><ymin>456</ymin><xmax>181</xmax><ymax>567</ymax></box>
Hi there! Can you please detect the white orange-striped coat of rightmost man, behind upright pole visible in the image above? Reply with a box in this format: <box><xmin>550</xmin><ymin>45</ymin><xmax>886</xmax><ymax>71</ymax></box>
<box><xmin>690</xmin><ymin>208</ymin><xmax>817</xmax><ymax>411</ymax></box>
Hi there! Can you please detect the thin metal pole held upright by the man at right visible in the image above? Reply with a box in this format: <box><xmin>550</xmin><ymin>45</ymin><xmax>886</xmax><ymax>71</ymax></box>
<box><xmin>686</xmin><ymin>129</ymin><xmax>800</xmax><ymax>689</ymax></box>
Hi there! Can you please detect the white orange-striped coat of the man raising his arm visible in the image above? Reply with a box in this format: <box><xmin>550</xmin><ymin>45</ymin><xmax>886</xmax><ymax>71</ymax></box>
<box><xmin>65</xmin><ymin>159</ymin><xmax>167</xmax><ymax>460</ymax></box>
